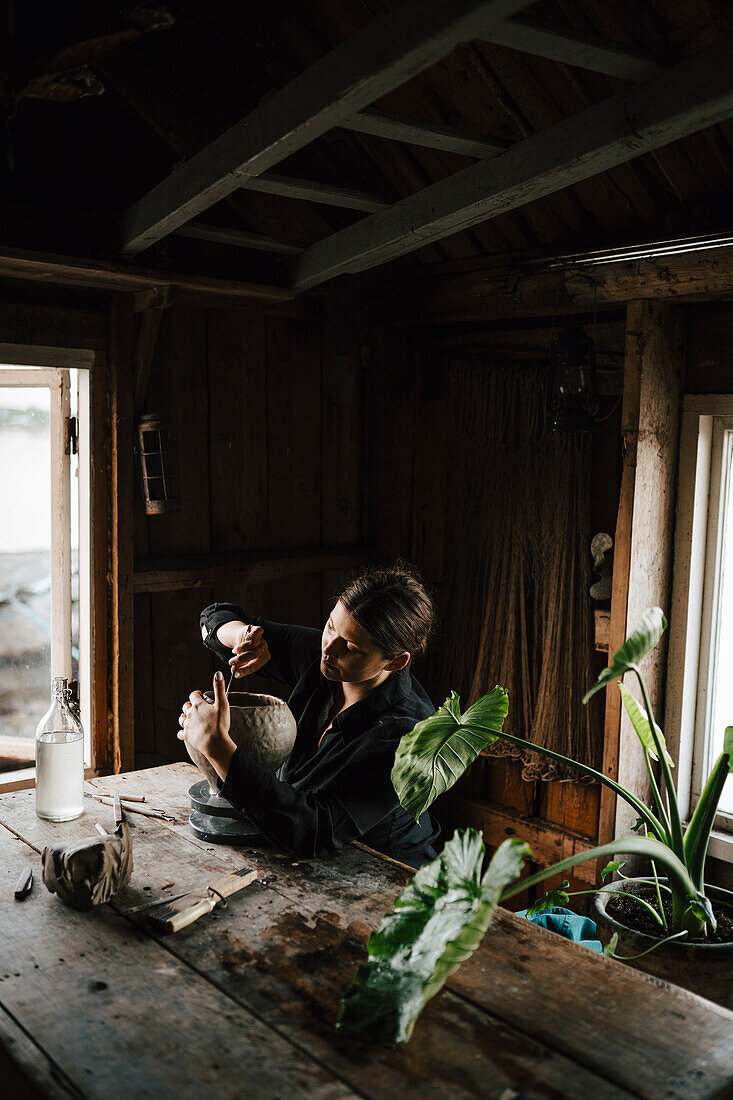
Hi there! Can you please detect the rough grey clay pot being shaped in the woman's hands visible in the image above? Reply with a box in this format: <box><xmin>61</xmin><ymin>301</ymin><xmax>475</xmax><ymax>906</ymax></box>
<box><xmin>186</xmin><ymin>691</ymin><xmax>297</xmax><ymax>798</ymax></box>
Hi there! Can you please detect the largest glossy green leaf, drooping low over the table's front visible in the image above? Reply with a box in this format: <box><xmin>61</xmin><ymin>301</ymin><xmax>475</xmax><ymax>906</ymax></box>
<box><xmin>338</xmin><ymin>829</ymin><xmax>530</xmax><ymax>1044</ymax></box>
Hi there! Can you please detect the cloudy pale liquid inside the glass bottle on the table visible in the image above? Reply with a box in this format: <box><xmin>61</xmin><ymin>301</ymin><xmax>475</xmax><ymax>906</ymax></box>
<box><xmin>35</xmin><ymin>729</ymin><xmax>84</xmax><ymax>822</ymax></box>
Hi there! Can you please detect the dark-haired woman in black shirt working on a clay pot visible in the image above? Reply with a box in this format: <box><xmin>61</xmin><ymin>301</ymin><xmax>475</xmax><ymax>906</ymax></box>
<box><xmin>178</xmin><ymin>564</ymin><xmax>439</xmax><ymax>867</ymax></box>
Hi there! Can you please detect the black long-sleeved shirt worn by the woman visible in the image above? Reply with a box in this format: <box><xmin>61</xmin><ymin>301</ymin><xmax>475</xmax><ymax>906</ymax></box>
<box><xmin>200</xmin><ymin>604</ymin><xmax>440</xmax><ymax>867</ymax></box>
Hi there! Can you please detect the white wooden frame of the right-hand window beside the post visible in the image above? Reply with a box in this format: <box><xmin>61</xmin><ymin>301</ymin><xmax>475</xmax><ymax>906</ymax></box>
<box><xmin>665</xmin><ymin>394</ymin><xmax>733</xmax><ymax>861</ymax></box>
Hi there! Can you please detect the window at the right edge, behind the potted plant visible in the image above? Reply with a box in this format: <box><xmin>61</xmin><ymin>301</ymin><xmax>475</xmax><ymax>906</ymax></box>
<box><xmin>666</xmin><ymin>395</ymin><xmax>733</xmax><ymax>860</ymax></box>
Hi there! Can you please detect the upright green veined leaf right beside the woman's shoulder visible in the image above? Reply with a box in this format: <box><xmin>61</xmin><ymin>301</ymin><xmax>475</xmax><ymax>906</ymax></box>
<box><xmin>392</xmin><ymin>686</ymin><xmax>508</xmax><ymax>821</ymax></box>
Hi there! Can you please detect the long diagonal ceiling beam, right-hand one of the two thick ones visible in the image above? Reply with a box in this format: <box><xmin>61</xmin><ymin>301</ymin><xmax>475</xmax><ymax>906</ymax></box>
<box><xmin>293</xmin><ymin>37</ymin><xmax>733</xmax><ymax>289</ymax></box>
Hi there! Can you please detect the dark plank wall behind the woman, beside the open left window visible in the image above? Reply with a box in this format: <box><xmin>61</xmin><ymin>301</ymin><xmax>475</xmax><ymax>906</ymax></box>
<box><xmin>134</xmin><ymin>306</ymin><xmax>364</xmax><ymax>760</ymax></box>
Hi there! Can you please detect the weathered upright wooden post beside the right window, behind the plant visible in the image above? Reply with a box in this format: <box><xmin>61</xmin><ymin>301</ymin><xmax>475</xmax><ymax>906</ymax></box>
<box><xmin>599</xmin><ymin>301</ymin><xmax>683</xmax><ymax>844</ymax></box>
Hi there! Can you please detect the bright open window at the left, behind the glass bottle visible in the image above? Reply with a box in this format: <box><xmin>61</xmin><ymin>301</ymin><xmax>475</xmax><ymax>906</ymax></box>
<box><xmin>0</xmin><ymin>366</ymin><xmax>90</xmax><ymax>787</ymax></box>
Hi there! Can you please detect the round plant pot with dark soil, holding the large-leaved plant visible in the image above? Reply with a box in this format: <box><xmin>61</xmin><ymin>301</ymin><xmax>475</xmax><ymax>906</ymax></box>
<box><xmin>591</xmin><ymin>878</ymin><xmax>733</xmax><ymax>1009</ymax></box>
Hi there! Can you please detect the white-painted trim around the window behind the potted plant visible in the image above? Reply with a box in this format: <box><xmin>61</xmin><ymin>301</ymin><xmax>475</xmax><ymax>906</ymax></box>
<box><xmin>665</xmin><ymin>394</ymin><xmax>733</xmax><ymax>861</ymax></box>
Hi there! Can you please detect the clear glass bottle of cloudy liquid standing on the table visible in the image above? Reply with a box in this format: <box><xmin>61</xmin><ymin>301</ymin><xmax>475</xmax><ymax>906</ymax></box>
<box><xmin>35</xmin><ymin>677</ymin><xmax>84</xmax><ymax>822</ymax></box>
